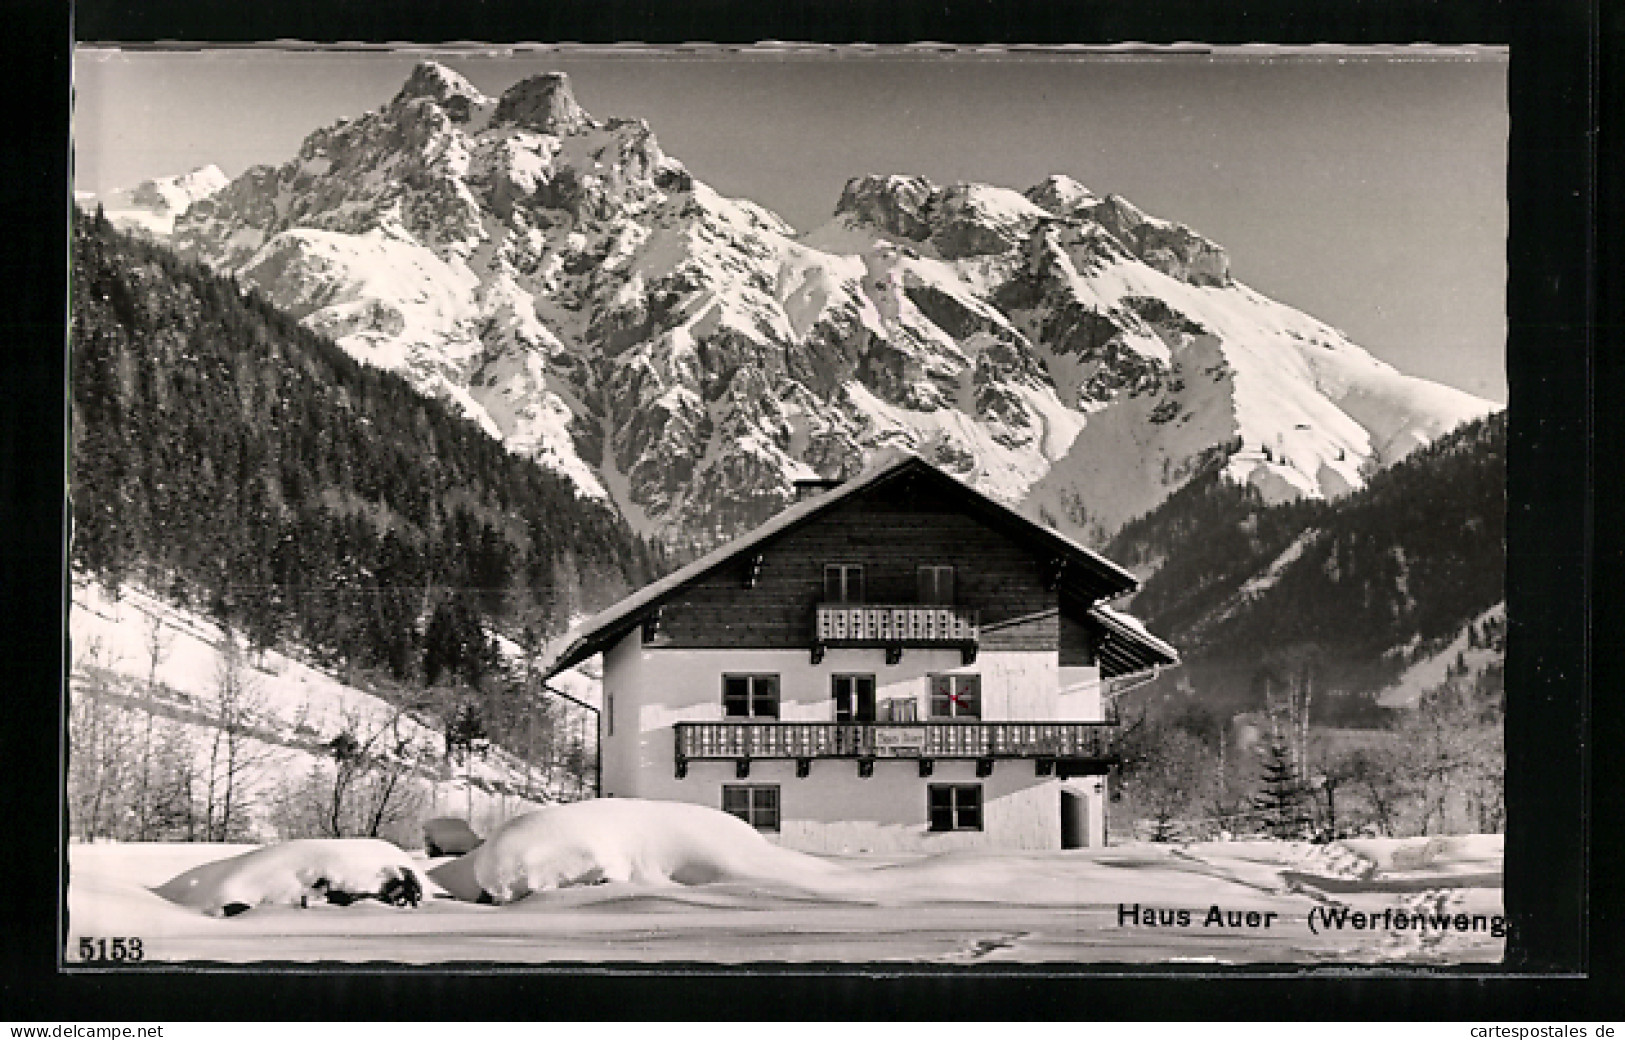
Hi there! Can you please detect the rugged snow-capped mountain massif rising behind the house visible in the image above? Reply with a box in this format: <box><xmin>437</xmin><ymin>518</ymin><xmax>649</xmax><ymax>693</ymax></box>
<box><xmin>172</xmin><ymin>62</ymin><xmax>1492</xmax><ymax>540</ymax></box>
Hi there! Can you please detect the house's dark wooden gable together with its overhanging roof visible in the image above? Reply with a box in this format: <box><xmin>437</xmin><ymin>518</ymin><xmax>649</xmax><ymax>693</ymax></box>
<box><xmin>546</xmin><ymin>453</ymin><xmax>1178</xmax><ymax>676</ymax></box>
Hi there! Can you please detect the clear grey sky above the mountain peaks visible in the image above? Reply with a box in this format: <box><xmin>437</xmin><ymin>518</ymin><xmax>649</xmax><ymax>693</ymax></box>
<box><xmin>73</xmin><ymin>49</ymin><xmax>1508</xmax><ymax>403</ymax></box>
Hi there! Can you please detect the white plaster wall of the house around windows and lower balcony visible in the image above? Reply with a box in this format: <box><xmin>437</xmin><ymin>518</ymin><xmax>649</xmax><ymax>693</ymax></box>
<box><xmin>603</xmin><ymin>631</ymin><xmax>1105</xmax><ymax>852</ymax></box>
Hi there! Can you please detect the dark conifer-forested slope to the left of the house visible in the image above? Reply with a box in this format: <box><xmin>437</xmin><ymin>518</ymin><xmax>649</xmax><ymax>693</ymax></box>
<box><xmin>72</xmin><ymin>213</ymin><xmax>663</xmax><ymax>684</ymax></box>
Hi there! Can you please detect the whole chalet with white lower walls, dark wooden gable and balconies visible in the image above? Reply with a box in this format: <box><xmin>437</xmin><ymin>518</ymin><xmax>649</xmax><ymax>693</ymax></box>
<box><xmin>548</xmin><ymin>455</ymin><xmax>1178</xmax><ymax>852</ymax></box>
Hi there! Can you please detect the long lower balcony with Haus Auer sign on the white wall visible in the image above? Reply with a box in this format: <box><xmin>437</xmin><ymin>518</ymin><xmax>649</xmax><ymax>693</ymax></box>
<box><xmin>674</xmin><ymin>722</ymin><xmax>1116</xmax><ymax>777</ymax></box>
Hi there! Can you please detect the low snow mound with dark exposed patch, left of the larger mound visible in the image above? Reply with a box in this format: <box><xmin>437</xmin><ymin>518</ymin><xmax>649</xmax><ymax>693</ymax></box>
<box><xmin>156</xmin><ymin>839</ymin><xmax>424</xmax><ymax>917</ymax></box>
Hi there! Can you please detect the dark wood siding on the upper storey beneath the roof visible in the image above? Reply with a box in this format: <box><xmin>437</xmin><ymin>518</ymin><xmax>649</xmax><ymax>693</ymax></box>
<box><xmin>652</xmin><ymin>481</ymin><xmax>1060</xmax><ymax>650</ymax></box>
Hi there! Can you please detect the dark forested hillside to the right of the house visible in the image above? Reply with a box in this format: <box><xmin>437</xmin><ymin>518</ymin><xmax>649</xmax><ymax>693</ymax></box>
<box><xmin>1107</xmin><ymin>413</ymin><xmax>1506</xmax><ymax>718</ymax></box>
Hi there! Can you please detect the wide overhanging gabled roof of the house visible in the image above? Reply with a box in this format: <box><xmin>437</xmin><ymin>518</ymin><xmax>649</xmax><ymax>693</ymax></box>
<box><xmin>543</xmin><ymin>450</ymin><xmax>1178</xmax><ymax>679</ymax></box>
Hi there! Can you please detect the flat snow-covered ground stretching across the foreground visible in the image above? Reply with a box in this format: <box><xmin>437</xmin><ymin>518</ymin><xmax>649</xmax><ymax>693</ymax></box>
<box><xmin>67</xmin><ymin>819</ymin><xmax>1505</xmax><ymax>964</ymax></box>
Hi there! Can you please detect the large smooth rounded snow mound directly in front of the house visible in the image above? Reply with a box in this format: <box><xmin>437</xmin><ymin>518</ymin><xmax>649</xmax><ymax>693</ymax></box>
<box><xmin>431</xmin><ymin>798</ymin><xmax>840</xmax><ymax>904</ymax></box>
